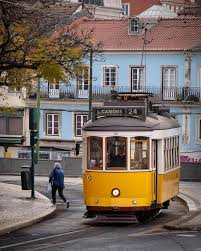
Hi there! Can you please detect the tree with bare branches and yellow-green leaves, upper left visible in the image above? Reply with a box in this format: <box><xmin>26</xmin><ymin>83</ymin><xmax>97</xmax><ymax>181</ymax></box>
<box><xmin>0</xmin><ymin>0</ymin><xmax>95</xmax><ymax>87</ymax></box>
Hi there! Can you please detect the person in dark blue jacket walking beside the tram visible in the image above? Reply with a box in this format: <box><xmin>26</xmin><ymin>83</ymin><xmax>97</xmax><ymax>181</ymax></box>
<box><xmin>49</xmin><ymin>163</ymin><xmax>69</xmax><ymax>208</ymax></box>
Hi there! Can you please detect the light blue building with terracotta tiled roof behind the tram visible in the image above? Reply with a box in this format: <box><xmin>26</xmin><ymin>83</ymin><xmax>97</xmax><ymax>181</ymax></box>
<box><xmin>0</xmin><ymin>18</ymin><xmax>201</xmax><ymax>167</ymax></box>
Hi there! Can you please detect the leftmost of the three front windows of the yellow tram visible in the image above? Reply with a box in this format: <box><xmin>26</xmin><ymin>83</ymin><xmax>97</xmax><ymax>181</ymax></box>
<box><xmin>87</xmin><ymin>137</ymin><xmax>103</xmax><ymax>170</ymax></box>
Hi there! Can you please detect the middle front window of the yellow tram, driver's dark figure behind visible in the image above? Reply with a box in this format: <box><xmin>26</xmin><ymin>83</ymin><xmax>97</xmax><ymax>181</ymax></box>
<box><xmin>106</xmin><ymin>137</ymin><xmax>127</xmax><ymax>169</ymax></box>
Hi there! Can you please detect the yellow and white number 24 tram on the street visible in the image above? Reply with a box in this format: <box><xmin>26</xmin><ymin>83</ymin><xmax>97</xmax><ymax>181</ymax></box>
<box><xmin>83</xmin><ymin>94</ymin><xmax>180</xmax><ymax>222</ymax></box>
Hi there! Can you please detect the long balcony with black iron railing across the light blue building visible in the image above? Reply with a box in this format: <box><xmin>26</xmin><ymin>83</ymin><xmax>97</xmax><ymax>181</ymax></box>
<box><xmin>30</xmin><ymin>85</ymin><xmax>201</xmax><ymax>103</ymax></box>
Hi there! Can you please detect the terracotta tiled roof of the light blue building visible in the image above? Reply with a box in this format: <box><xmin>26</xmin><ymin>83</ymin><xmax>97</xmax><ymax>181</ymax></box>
<box><xmin>77</xmin><ymin>18</ymin><xmax>201</xmax><ymax>51</ymax></box>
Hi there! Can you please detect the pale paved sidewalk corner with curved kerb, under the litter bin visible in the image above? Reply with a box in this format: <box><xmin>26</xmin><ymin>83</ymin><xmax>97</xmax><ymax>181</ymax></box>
<box><xmin>0</xmin><ymin>182</ymin><xmax>56</xmax><ymax>235</ymax></box>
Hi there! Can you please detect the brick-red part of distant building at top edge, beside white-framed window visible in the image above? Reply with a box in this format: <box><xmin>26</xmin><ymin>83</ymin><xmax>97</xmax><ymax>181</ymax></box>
<box><xmin>122</xmin><ymin>0</ymin><xmax>160</xmax><ymax>16</ymax></box>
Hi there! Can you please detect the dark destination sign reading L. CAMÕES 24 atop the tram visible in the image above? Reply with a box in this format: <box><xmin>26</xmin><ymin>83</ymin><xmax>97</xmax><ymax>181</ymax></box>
<box><xmin>93</xmin><ymin>106</ymin><xmax>145</xmax><ymax>119</ymax></box>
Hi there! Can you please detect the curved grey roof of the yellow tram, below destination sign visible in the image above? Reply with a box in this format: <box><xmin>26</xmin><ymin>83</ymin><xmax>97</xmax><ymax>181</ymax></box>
<box><xmin>83</xmin><ymin>114</ymin><xmax>180</xmax><ymax>131</ymax></box>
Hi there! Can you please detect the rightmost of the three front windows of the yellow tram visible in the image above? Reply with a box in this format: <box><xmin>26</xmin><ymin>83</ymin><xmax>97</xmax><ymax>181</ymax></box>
<box><xmin>130</xmin><ymin>137</ymin><xmax>149</xmax><ymax>170</ymax></box>
